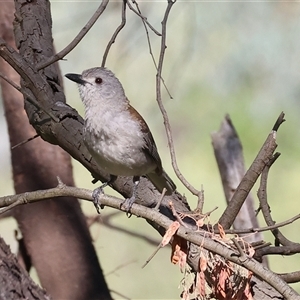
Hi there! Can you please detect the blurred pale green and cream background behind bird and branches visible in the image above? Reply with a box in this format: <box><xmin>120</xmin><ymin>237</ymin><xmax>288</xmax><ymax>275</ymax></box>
<box><xmin>0</xmin><ymin>0</ymin><xmax>300</xmax><ymax>299</ymax></box>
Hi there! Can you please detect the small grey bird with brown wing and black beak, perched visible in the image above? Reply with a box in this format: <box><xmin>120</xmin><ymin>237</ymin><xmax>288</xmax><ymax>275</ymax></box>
<box><xmin>65</xmin><ymin>67</ymin><xmax>176</xmax><ymax>213</ymax></box>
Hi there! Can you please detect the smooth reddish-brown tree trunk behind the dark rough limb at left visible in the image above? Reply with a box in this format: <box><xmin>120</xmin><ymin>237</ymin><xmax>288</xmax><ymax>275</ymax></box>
<box><xmin>0</xmin><ymin>1</ymin><xmax>111</xmax><ymax>299</ymax></box>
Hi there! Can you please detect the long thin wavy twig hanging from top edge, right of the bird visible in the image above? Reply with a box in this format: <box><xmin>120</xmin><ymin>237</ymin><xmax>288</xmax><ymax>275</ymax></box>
<box><xmin>156</xmin><ymin>0</ymin><xmax>201</xmax><ymax>198</ymax></box>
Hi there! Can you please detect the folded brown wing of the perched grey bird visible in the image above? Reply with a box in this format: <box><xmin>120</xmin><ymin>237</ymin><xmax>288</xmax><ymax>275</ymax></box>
<box><xmin>128</xmin><ymin>105</ymin><xmax>162</xmax><ymax>174</ymax></box>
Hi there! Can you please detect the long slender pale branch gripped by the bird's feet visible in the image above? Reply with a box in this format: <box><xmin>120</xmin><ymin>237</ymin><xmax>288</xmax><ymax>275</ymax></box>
<box><xmin>0</xmin><ymin>183</ymin><xmax>299</xmax><ymax>300</ymax></box>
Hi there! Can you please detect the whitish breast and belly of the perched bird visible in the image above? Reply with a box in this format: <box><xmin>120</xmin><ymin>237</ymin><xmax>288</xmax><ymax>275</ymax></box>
<box><xmin>84</xmin><ymin>110</ymin><xmax>156</xmax><ymax>176</ymax></box>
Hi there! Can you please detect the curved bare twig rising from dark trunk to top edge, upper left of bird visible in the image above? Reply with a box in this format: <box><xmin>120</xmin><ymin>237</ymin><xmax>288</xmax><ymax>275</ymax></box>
<box><xmin>37</xmin><ymin>0</ymin><xmax>109</xmax><ymax>71</ymax></box>
